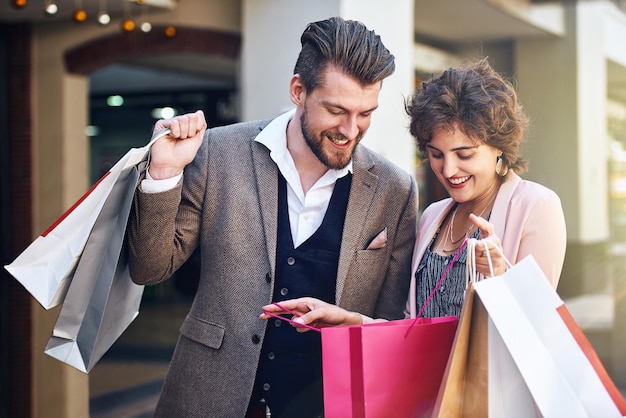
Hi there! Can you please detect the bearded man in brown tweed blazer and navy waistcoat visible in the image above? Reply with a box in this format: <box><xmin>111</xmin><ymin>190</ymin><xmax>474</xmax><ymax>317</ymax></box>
<box><xmin>129</xmin><ymin>14</ymin><xmax>417</xmax><ymax>418</ymax></box>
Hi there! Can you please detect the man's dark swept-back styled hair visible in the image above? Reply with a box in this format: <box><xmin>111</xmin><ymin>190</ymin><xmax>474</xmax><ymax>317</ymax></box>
<box><xmin>294</xmin><ymin>17</ymin><xmax>396</xmax><ymax>91</ymax></box>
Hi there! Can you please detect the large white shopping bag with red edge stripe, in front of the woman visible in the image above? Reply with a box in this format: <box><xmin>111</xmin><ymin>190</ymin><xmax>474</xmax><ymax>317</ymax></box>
<box><xmin>468</xmin><ymin>250</ymin><xmax>626</xmax><ymax>418</ymax></box>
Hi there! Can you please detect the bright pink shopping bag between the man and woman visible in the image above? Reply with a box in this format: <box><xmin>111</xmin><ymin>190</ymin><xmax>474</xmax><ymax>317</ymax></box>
<box><xmin>322</xmin><ymin>317</ymin><xmax>457</xmax><ymax>418</ymax></box>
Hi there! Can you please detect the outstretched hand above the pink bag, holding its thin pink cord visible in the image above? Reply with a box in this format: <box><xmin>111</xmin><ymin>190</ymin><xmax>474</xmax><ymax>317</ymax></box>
<box><xmin>260</xmin><ymin>297</ymin><xmax>362</xmax><ymax>332</ymax></box>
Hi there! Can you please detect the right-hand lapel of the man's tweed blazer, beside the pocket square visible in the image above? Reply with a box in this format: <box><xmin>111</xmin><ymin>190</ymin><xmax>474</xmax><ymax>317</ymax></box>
<box><xmin>336</xmin><ymin>147</ymin><xmax>379</xmax><ymax>301</ymax></box>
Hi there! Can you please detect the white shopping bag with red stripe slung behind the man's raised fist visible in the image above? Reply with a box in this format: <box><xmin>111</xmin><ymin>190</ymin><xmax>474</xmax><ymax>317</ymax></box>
<box><xmin>4</xmin><ymin>129</ymin><xmax>169</xmax><ymax>309</ymax></box>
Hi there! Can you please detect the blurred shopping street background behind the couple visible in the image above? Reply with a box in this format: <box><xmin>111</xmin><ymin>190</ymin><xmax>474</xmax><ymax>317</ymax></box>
<box><xmin>0</xmin><ymin>0</ymin><xmax>626</xmax><ymax>417</ymax></box>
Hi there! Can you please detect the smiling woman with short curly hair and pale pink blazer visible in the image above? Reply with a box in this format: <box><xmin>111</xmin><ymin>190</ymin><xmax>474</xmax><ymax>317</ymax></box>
<box><xmin>261</xmin><ymin>59</ymin><xmax>566</xmax><ymax>331</ymax></box>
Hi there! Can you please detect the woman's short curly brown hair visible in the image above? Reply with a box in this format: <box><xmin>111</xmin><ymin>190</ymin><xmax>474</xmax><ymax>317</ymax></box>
<box><xmin>405</xmin><ymin>58</ymin><xmax>529</xmax><ymax>174</ymax></box>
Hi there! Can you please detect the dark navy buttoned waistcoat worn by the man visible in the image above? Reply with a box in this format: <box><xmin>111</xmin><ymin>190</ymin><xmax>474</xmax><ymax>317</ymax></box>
<box><xmin>251</xmin><ymin>174</ymin><xmax>352</xmax><ymax>418</ymax></box>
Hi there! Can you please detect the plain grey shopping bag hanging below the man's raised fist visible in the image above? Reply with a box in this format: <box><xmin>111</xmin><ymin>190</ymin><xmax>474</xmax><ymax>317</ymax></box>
<box><xmin>45</xmin><ymin>162</ymin><xmax>143</xmax><ymax>373</ymax></box>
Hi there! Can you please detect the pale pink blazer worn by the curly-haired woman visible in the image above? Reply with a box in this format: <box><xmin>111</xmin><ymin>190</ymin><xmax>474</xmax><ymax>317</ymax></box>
<box><xmin>405</xmin><ymin>172</ymin><xmax>567</xmax><ymax>317</ymax></box>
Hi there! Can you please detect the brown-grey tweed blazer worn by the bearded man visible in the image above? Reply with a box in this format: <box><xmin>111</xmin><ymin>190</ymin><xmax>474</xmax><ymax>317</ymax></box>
<box><xmin>128</xmin><ymin>121</ymin><xmax>417</xmax><ymax>418</ymax></box>
